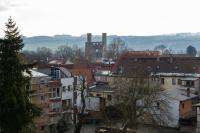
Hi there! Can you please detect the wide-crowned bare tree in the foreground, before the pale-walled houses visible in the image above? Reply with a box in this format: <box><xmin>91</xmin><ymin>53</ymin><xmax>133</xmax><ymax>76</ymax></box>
<box><xmin>113</xmin><ymin>75</ymin><xmax>168</xmax><ymax>132</ymax></box>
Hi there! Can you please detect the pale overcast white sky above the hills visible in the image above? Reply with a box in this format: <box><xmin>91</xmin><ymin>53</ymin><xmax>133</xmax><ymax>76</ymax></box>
<box><xmin>0</xmin><ymin>0</ymin><xmax>200</xmax><ymax>36</ymax></box>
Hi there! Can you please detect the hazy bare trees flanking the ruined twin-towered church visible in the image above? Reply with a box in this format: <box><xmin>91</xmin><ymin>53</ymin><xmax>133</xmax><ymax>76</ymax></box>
<box><xmin>22</xmin><ymin>38</ymin><xmax>128</xmax><ymax>63</ymax></box>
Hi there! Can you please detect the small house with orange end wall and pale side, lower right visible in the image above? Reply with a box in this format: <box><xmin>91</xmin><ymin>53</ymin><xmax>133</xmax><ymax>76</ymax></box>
<box><xmin>162</xmin><ymin>88</ymin><xmax>199</xmax><ymax>128</ymax></box>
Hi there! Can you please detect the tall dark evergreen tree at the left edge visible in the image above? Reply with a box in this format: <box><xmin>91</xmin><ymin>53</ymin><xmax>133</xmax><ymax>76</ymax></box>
<box><xmin>0</xmin><ymin>18</ymin><xmax>40</xmax><ymax>133</ymax></box>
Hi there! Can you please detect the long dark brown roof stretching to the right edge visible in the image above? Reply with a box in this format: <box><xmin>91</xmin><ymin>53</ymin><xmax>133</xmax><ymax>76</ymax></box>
<box><xmin>112</xmin><ymin>52</ymin><xmax>200</xmax><ymax>74</ymax></box>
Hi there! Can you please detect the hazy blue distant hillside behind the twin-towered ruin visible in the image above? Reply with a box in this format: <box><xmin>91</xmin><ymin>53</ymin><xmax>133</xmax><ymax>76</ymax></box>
<box><xmin>24</xmin><ymin>33</ymin><xmax>200</xmax><ymax>51</ymax></box>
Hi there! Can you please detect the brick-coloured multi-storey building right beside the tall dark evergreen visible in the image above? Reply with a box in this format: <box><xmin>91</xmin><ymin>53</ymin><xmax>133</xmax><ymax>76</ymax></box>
<box><xmin>31</xmin><ymin>70</ymin><xmax>61</xmax><ymax>133</ymax></box>
